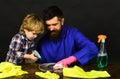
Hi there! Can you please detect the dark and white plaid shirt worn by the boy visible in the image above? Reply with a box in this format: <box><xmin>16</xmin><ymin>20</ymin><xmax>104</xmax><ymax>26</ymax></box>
<box><xmin>6</xmin><ymin>33</ymin><xmax>35</xmax><ymax>63</ymax></box>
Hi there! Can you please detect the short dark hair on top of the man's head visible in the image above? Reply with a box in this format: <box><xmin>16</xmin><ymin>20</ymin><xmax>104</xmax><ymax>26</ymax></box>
<box><xmin>42</xmin><ymin>5</ymin><xmax>63</xmax><ymax>21</ymax></box>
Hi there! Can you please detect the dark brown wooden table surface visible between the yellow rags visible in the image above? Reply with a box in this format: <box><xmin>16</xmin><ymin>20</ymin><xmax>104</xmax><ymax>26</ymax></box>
<box><xmin>4</xmin><ymin>63</ymin><xmax>120</xmax><ymax>79</ymax></box>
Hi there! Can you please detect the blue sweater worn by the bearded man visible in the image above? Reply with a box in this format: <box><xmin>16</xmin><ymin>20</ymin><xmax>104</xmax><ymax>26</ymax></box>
<box><xmin>37</xmin><ymin>26</ymin><xmax>98</xmax><ymax>65</ymax></box>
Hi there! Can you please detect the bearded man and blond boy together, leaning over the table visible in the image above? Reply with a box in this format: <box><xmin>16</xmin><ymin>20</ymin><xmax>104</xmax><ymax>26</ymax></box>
<box><xmin>6</xmin><ymin>6</ymin><xmax>98</xmax><ymax>69</ymax></box>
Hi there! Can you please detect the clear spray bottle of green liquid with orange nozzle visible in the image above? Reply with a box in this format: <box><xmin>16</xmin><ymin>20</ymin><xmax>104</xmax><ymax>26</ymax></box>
<box><xmin>97</xmin><ymin>35</ymin><xmax>108</xmax><ymax>70</ymax></box>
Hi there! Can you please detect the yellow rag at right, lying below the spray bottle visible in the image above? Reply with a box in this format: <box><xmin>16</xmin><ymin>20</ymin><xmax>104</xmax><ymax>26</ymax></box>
<box><xmin>63</xmin><ymin>65</ymin><xmax>110</xmax><ymax>78</ymax></box>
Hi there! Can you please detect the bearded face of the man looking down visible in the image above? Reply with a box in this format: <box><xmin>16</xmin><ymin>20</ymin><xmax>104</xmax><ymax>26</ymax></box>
<box><xmin>46</xmin><ymin>17</ymin><xmax>64</xmax><ymax>40</ymax></box>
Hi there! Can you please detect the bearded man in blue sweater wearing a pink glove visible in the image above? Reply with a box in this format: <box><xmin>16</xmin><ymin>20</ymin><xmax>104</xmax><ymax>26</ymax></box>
<box><xmin>37</xmin><ymin>6</ymin><xmax>98</xmax><ymax>69</ymax></box>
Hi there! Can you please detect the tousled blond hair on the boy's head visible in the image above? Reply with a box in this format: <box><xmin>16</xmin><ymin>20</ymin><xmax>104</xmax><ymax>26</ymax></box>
<box><xmin>19</xmin><ymin>13</ymin><xmax>44</xmax><ymax>34</ymax></box>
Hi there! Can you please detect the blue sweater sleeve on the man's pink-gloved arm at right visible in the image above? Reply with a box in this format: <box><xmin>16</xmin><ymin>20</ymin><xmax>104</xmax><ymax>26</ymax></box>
<box><xmin>73</xmin><ymin>29</ymin><xmax>98</xmax><ymax>65</ymax></box>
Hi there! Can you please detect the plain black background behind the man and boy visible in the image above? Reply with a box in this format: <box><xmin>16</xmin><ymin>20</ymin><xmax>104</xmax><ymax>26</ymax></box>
<box><xmin>0</xmin><ymin>0</ymin><xmax>120</xmax><ymax>62</ymax></box>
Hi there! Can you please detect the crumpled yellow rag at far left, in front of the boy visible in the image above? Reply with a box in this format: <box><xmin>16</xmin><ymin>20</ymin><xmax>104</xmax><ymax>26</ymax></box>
<box><xmin>0</xmin><ymin>62</ymin><xmax>28</xmax><ymax>78</ymax></box>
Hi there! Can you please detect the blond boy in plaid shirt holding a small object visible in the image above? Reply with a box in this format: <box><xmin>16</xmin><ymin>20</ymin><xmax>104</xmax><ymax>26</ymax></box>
<box><xmin>6</xmin><ymin>13</ymin><xmax>44</xmax><ymax>65</ymax></box>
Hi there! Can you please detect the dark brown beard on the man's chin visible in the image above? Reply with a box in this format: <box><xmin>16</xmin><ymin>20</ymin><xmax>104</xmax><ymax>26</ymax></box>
<box><xmin>48</xmin><ymin>30</ymin><xmax>61</xmax><ymax>41</ymax></box>
